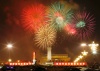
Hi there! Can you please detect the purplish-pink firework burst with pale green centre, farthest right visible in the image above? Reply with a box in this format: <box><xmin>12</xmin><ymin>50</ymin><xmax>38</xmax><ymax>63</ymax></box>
<box><xmin>72</xmin><ymin>11</ymin><xmax>95</xmax><ymax>39</ymax></box>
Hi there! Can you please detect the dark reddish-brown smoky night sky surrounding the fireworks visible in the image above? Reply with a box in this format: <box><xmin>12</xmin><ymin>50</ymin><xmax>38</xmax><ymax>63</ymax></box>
<box><xmin>0</xmin><ymin>0</ymin><xmax>100</xmax><ymax>61</ymax></box>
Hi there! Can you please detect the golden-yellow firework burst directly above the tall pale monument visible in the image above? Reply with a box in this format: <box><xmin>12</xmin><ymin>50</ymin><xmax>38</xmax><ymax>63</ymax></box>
<box><xmin>35</xmin><ymin>24</ymin><xmax>56</xmax><ymax>49</ymax></box>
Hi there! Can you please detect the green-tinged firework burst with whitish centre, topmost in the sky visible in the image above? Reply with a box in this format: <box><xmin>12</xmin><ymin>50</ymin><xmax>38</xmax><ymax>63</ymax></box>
<box><xmin>47</xmin><ymin>2</ymin><xmax>72</xmax><ymax>29</ymax></box>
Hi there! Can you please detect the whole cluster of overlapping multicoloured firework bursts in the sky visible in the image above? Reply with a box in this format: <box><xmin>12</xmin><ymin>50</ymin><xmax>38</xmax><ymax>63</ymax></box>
<box><xmin>19</xmin><ymin>1</ymin><xmax>94</xmax><ymax>49</ymax></box>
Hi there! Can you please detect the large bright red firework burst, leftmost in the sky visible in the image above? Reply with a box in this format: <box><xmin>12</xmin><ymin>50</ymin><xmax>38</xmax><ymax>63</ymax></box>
<box><xmin>22</xmin><ymin>4</ymin><xmax>46</xmax><ymax>32</ymax></box>
